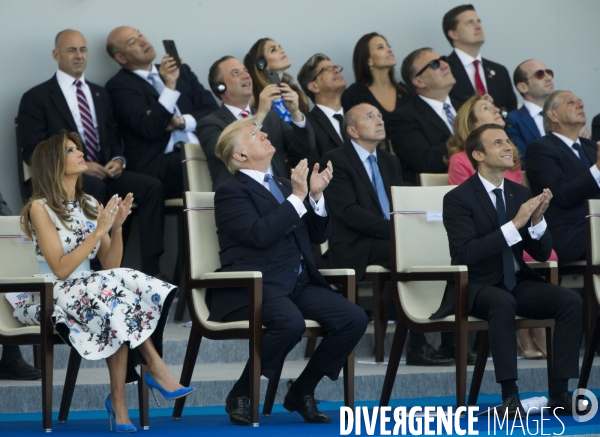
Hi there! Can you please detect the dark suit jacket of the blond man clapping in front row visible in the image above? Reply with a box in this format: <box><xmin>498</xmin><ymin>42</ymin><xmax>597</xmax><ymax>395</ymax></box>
<box><xmin>207</xmin><ymin>172</ymin><xmax>331</xmax><ymax>320</ymax></box>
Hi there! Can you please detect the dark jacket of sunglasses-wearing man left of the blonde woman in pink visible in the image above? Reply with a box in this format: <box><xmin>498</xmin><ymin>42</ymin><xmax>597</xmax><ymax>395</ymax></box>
<box><xmin>386</xmin><ymin>95</ymin><xmax>460</xmax><ymax>184</ymax></box>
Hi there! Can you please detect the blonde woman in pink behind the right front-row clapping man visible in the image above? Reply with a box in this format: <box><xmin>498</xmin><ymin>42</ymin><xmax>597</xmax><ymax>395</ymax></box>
<box><xmin>445</xmin><ymin>94</ymin><xmax>558</xmax><ymax>359</ymax></box>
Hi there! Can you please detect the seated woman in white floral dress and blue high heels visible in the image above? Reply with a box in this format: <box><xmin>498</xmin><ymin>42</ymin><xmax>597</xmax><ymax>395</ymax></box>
<box><xmin>14</xmin><ymin>132</ymin><xmax>193</xmax><ymax>432</ymax></box>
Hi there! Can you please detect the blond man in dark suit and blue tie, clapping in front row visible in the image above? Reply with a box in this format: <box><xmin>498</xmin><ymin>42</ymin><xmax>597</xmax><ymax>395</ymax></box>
<box><xmin>213</xmin><ymin>117</ymin><xmax>367</xmax><ymax>425</ymax></box>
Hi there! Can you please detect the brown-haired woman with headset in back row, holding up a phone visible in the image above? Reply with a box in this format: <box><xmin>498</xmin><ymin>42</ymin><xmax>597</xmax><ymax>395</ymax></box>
<box><xmin>244</xmin><ymin>38</ymin><xmax>308</xmax><ymax>114</ymax></box>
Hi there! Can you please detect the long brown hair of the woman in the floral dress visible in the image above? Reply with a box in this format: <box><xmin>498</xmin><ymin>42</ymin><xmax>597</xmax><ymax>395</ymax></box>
<box><xmin>21</xmin><ymin>131</ymin><xmax>98</xmax><ymax>237</ymax></box>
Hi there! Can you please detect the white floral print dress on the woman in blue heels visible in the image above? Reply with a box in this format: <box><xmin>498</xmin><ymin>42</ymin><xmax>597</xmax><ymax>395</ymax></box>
<box><xmin>13</xmin><ymin>199</ymin><xmax>176</xmax><ymax>360</ymax></box>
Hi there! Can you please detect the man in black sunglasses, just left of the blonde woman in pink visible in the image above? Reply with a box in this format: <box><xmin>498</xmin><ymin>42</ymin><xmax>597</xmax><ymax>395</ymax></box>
<box><xmin>387</xmin><ymin>48</ymin><xmax>459</xmax><ymax>185</ymax></box>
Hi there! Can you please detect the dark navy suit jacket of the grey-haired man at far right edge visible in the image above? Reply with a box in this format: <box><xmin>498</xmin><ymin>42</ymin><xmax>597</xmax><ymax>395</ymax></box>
<box><xmin>526</xmin><ymin>134</ymin><xmax>600</xmax><ymax>264</ymax></box>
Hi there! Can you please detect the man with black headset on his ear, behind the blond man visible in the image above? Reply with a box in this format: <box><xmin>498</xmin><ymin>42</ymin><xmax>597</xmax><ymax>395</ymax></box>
<box><xmin>196</xmin><ymin>56</ymin><xmax>316</xmax><ymax>191</ymax></box>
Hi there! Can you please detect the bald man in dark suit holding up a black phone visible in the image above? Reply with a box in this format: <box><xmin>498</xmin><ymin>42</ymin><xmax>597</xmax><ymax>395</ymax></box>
<box><xmin>106</xmin><ymin>26</ymin><xmax>218</xmax><ymax>199</ymax></box>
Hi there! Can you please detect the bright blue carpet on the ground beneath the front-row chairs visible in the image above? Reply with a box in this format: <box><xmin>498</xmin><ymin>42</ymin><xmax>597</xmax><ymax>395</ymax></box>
<box><xmin>0</xmin><ymin>390</ymin><xmax>600</xmax><ymax>437</ymax></box>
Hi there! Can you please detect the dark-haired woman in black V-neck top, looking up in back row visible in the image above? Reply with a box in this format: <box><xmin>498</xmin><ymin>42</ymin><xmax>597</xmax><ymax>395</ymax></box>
<box><xmin>342</xmin><ymin>32</ymin><xmax>409</xmax><ymax>131</ymax></box>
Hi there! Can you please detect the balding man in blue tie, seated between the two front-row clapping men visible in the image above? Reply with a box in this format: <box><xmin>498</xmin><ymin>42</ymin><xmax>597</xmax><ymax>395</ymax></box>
<box><xmin>322</xmin><ymin>103</ymin><xmax>454</xmax><ymax>366</ymax></box>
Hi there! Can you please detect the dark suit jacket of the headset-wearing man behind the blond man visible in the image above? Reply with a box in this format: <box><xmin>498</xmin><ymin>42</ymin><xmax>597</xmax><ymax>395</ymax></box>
<box><xmin>196</xmin><ymin>105</ymin><xmax>315</xmax><ymax>191</ymax></box>
